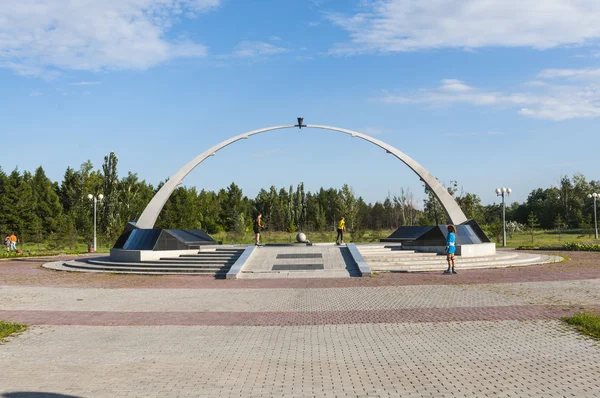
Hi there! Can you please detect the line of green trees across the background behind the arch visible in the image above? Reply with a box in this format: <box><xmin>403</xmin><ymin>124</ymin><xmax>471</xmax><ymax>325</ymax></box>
<box><xmin>0</xmin><ymin>153</ymin><xmax>600</xmax><ymax>248</ymax></box>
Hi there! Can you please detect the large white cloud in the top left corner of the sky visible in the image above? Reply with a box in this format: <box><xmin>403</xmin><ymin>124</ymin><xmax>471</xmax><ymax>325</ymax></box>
<box><xmin>0</xmin><ymin>0</ymin><xmax>220</xmax><ymax>77</ymax></box>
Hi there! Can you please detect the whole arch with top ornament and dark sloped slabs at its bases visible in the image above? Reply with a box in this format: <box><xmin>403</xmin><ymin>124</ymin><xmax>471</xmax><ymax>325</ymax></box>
<box><xmin>111</xmin><ymin>118</ymin><xmax>495</xmax><ymax>256</ymax></box>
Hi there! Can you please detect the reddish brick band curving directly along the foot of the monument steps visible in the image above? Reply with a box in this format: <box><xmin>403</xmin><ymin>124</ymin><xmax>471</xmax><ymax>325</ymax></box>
<box><xmin>0</xmin><ymin>252</ymin><xmax>600</xmax><ymax>289</ymax></box>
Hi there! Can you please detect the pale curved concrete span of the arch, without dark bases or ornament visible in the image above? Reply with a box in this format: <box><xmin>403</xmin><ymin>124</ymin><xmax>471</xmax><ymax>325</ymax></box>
<box><xmin>136</xmin><ymin>124</ymin><xmax>467</xmax><ymax>229</ymax></box>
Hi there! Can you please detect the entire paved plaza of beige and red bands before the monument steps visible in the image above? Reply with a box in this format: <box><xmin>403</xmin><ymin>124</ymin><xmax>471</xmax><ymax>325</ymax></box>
<box><xmin>0</xmin><ymin>253</ymin><xmax>600</xmax><ymax>397</ymax></box>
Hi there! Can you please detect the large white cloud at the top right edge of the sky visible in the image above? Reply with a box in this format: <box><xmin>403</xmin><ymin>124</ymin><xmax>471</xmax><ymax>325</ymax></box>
<box><xmin>327</xmin><ymin>0</ymin><xmax>600</xmax><ymax>55</ymax></box>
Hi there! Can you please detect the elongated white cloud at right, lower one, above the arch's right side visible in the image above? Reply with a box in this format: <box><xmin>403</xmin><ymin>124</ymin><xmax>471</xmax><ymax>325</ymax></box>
<box><xmin>372</xmin><ymin>69</ymin><xmax>600</xmax><ymax>121</ymax></box>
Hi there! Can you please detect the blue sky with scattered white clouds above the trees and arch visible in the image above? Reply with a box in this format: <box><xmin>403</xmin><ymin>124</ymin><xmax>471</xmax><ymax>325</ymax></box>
<box><xmin>0</xmin><ymin>0</ymin><xmax>600</xmax><ymax>208</ymax></box>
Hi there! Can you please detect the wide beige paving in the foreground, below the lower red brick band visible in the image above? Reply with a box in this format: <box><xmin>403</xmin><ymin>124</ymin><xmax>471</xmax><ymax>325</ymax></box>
<box><xmin>0</xmin><ymin>321</ymin><xmax>600</xmax><ymax>397</ymax></box>
